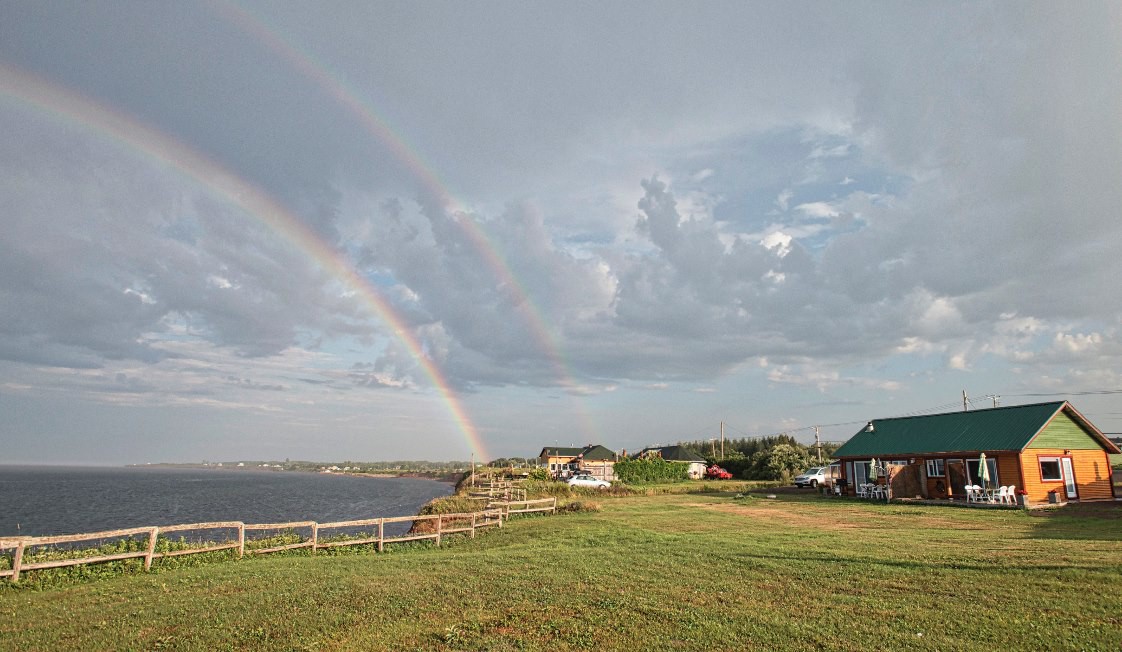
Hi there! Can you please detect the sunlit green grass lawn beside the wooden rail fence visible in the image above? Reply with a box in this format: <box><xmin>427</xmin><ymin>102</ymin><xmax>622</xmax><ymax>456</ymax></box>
<box><xmin>0</xmin><ymin>493</ymin><xmax>1122</xmax><ymax>651</ymax></box>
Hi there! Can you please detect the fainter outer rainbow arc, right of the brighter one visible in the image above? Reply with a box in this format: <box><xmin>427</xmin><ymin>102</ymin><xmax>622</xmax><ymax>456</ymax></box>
<box><xmin>211</xmin><ymin>1</ymin><xmax>597</xmax><ymax>442</ymax></box>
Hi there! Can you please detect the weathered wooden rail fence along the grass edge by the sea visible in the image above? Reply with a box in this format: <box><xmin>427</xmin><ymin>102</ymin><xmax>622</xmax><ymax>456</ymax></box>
<box><xmin>0</xmin><ymin>498</ymin><xmax>557</xmax><ymax>582</ymax></box>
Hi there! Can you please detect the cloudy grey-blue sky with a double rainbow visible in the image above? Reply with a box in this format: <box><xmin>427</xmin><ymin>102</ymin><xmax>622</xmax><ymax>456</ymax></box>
<box><xmin>0</xmin><ymin>0</ymin><xmax>1122</xmax><ymax>465</ymax></box>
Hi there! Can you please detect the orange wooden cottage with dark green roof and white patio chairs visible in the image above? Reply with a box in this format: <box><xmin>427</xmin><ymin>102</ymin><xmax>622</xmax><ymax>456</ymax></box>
<box><xmin>834</xmin><ymin>401</ymin><xmax>1120</xmax><ymax>503</ymax></box>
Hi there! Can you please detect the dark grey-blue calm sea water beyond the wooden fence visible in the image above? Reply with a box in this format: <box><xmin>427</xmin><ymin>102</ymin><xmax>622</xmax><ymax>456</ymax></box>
<box><xmin>0</xmin><ymin>466</ymin><xmax>452</xmax><ymax>536</ymax></box>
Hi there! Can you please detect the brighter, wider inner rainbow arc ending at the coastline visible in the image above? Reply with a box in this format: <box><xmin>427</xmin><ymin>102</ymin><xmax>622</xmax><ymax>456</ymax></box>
<box><xmin>0</xmin><ymin>63</ymin><xmax>490</xmax><ymax>460</ymax></box>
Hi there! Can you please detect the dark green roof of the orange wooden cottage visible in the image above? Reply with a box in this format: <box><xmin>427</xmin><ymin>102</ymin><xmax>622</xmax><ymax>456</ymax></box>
<box><xmin>834</xmin><ymin>401</ymin><xmax>1114</xmax><ymax>458</ymax></box>
